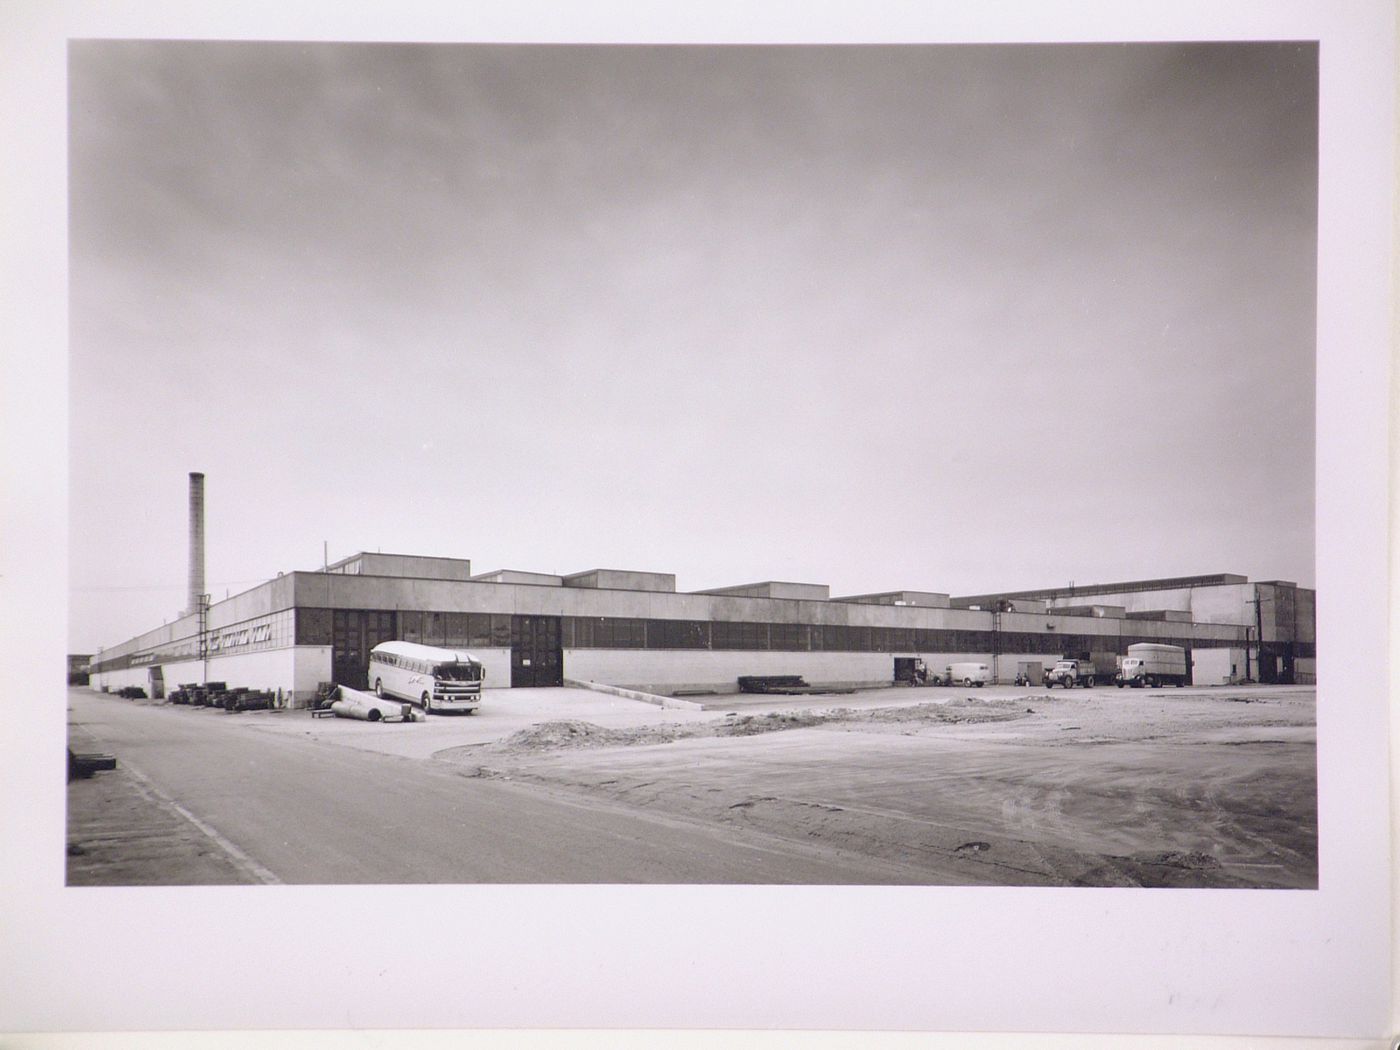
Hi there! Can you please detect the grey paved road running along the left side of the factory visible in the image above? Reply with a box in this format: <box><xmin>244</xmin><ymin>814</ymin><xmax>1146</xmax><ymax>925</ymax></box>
<box><xmin>69</xmin><ymin>690</ymin><xmax>904</xmax><ymax>885</ymax></box>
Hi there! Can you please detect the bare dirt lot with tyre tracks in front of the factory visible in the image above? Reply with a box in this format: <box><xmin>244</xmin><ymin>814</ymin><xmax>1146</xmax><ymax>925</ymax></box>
<box><xmin>434</xmin><ymin>687</ymin><xmax>1317</xmax><ymax>889</ymax></box>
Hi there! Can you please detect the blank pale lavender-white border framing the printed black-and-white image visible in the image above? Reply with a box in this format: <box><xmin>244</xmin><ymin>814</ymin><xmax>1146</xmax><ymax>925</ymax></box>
<box><xmin>0</xmin><ymin>6</ymin><xmax>1392</xmax><ymax>1036</ymax></box>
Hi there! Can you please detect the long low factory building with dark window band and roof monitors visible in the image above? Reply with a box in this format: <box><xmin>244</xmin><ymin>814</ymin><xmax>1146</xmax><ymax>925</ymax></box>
<box><xmin>90</xmin><ymin>551</ymin><xmax>1316</xmax><ymax>704</ymax></box>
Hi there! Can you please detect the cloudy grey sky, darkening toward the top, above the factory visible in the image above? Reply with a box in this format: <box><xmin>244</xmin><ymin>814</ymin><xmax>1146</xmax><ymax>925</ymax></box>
<box><xmin>69</xmin><ymin>42</ymin><xmax>1317</xmax><ymax>651</ymax></box>
